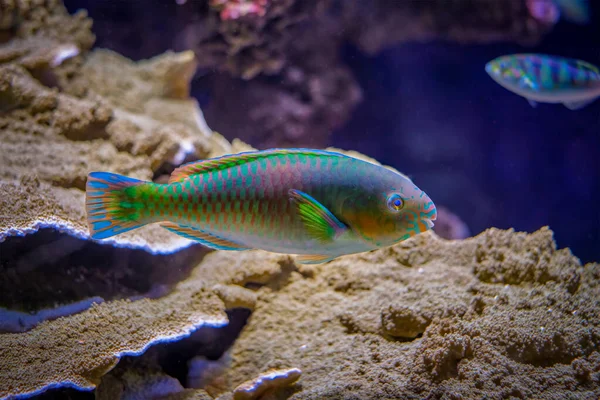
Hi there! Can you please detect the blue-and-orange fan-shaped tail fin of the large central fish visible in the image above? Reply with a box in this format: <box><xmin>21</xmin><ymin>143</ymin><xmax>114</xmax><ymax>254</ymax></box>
<box><xmin>85</xmin><ymin>172</ymin><xmax>154</xmax><ymax>239</ymax></box>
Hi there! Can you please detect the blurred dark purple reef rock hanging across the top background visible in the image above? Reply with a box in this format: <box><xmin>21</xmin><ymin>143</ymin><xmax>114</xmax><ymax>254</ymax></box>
<box><xmin>72</xmin><ymin>0</ymin><xmax>552</xmax><ymax>148</ymax></box>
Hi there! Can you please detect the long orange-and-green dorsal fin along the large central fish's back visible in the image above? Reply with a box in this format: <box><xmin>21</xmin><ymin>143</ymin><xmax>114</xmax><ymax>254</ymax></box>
<box><xmin>169</xmin><ymin>149</ymin><xmax>348</xmax><ymax>183</ymax></box>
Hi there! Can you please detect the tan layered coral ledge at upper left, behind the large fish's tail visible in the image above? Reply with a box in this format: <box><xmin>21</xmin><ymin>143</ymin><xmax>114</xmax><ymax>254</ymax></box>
<box><xmin>0</xmin><ymin>2</ymin><xmax>247</xmax><ymax>252</ymax></box>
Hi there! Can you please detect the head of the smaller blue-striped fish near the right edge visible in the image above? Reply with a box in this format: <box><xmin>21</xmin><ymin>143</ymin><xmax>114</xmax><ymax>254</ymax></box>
<box><xmin>485</xmin><ymin>56</ymin><xmax>538</xmax><ymax>93</ymax></box>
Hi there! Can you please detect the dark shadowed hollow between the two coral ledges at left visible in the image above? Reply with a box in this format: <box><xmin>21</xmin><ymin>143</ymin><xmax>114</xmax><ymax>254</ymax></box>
<box><xmin>0</xmin><ymin>229</ymin><xmax>210</xmax><ymax>332</ymax></box>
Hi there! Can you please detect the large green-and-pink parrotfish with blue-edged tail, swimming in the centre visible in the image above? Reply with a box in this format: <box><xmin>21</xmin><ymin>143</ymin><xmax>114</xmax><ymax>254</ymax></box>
<box><xmin>86</xmin><ymin>149</ymin><xmax>437</xmax><ymax>264</ymax></box>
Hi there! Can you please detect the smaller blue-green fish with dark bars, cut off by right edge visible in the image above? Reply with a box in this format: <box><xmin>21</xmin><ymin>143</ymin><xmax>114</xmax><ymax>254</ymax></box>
<box><xmin>485</xmin><ymin>54</ymin><xmax>600</xmax><ymax>110</ymax></box>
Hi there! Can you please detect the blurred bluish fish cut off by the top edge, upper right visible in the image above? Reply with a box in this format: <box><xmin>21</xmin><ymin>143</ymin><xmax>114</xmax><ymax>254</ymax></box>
<box><xmin>526</xmin><ymin>0</ymin><xmax>590</xmax><ymax>25</ymax></box>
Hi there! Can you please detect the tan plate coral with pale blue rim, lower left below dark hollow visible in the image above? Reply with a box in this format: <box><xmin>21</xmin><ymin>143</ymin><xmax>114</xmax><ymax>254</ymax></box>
<box><xmin>0</xmin><ymin>248</ymin><xmax>288</xmax><ymax>398</ymax></box>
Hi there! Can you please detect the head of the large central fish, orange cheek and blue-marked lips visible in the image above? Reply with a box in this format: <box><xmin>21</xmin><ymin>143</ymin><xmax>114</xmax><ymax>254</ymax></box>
<box><xmin>344</xmin><ymin>169</ymin><xmax>437</xmax><ymax>248</ymax></box>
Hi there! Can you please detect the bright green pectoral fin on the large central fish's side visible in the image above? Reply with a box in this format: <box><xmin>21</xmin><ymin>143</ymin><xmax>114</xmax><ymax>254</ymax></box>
<box><xmin>288</xmin><ymin>189</ymin><xmax>348</xmax><ymax>242</ymax></box>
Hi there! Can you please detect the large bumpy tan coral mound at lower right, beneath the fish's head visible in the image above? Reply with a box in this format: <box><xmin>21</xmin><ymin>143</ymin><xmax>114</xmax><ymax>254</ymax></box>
<box><xmin>221</xmin><ymin>228</ymin><xmax>600</xmax><ymax>399</ymax></box>
